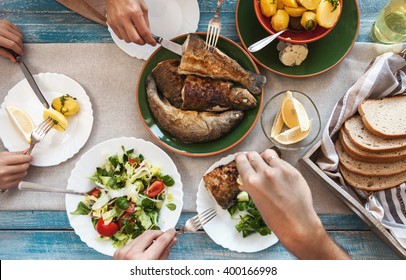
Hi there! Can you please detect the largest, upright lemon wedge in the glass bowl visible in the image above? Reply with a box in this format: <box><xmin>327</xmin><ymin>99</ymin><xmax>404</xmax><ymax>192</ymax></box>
<box><xmin>282</xmin><ymin>91</ymin><xmax>310</xmax><ymax>132</ymax></box>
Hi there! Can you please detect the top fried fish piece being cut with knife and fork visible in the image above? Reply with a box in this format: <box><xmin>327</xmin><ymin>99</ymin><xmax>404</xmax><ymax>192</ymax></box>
<box><xmin>178</xmin><ymin>34</ymin><xmax>266</xmax><ymax>94</ymax></box>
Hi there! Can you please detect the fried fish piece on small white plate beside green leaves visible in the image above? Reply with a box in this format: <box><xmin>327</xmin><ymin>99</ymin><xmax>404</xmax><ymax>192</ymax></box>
<box><xmin>203</xmin><ymin>160</ymin><xmax>240</xmax><ymax>209</ymax></box>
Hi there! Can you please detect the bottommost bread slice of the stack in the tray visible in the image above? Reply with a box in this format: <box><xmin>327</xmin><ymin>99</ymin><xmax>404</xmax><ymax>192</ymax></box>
<box><xmin>339</xmin><ymin>164</ymin><xmax>406</xmax><ymax>191</ymax></box>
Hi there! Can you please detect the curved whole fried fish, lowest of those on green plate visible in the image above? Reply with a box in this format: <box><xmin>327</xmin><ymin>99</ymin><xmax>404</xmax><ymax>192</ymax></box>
<box><xmin>147</xmin><ymin>74</ymin><xmax>244</xmax><ymax>143</ymax></box>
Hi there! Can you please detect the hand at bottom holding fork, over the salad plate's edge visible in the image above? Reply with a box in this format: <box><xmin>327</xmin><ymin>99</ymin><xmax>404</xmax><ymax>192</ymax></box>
<box><xmin>113</xmin><ymin>229</ymin><xmax>177</xmax><ymax>260</ymax></box>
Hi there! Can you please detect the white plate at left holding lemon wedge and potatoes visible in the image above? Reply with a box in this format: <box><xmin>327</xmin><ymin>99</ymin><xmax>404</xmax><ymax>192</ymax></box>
<box><xmin>0</xmin><ymin>73</ymin><xmax>93</xmax><ymax>166</ymax></box>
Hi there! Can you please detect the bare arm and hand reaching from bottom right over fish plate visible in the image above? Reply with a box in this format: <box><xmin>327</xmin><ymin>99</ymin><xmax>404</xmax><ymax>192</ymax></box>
<box><xmin>236</xmin><ymin>149</ymin><xmax>349</xmax><ymax>259</ymax></box>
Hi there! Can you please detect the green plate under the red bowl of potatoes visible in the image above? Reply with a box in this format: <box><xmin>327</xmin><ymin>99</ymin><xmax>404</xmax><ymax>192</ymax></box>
<box><xmin>235</xmin><ymin>0</ymin><xmax>360</xmax><ymax>78</ymax></box>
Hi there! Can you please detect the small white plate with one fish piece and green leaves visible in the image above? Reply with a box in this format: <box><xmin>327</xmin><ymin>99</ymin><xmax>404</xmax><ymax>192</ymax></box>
<box><xmin>196</xmin><ymin>154</ymin><xmax>278</xmax><ymax>253</ymax></box>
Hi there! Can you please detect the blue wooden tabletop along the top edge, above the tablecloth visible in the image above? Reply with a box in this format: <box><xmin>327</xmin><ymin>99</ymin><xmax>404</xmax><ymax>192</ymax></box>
<box><xmin>0</xmin><ymin>0</ymin><xmax>385</xmax><ymax>43</ymax></box>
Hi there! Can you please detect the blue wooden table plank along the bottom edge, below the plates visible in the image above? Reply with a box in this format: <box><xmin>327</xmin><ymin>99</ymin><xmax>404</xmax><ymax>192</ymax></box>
<box><xmin>0</xmin><ymin>230</ymin><xmax>398</xmax><ymax>260</ymax></box>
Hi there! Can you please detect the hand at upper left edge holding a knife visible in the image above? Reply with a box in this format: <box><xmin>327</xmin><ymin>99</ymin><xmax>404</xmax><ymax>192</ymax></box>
<box><xmin>0</xmin><ymin>20</ymin><xmax>23</xmax><ymax>63</ymax></box>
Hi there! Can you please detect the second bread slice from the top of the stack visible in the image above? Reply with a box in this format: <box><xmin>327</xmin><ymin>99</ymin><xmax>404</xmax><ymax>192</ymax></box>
<box><xmin>344</xmin><ymin>115</ymin><xmax>406</xmax><ymax>152</ymax></box>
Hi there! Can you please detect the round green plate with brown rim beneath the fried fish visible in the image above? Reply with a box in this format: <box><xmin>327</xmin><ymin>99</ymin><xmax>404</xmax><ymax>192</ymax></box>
<box><xmin>136</xmin><ymin>33</ymin><xmax>265</xmax><ymax>157</ymax></box>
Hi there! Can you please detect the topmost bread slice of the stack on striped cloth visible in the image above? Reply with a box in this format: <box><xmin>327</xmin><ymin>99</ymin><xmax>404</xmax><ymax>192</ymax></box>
<box><xmin>358</xmin><ymin>96</ymin><xmax>406</xmax><ymax>138</ymax></box>
